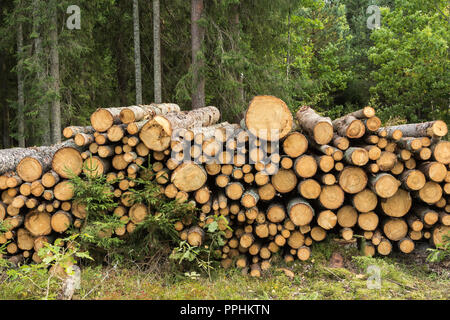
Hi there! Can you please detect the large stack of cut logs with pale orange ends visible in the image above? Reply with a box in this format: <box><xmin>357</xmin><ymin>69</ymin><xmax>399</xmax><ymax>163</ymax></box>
<box><xmin>0</xmin><ymin>96</ymin><xmax>450</xmax><ymax>276</ymax></box>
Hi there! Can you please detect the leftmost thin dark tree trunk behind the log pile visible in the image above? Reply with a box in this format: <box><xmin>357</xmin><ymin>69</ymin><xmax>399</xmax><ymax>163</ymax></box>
<box><xmin>17</xmin><ymin>18</ymin><xmax>25</xmax><ymax>148</ymax></box>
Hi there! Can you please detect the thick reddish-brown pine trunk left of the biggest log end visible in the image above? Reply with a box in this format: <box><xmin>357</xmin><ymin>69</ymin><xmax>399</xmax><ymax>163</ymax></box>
<box><xmin>191</xmin><ymin>0</ymin><xmax>205</xmax><ymax>109</ymax></box>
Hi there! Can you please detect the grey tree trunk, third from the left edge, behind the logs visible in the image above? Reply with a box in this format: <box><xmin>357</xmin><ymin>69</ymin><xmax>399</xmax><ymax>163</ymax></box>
<box><xmin>50</xmin><ymin>2</ymin><xmax>61</xmax><ymax>144</ymax></box>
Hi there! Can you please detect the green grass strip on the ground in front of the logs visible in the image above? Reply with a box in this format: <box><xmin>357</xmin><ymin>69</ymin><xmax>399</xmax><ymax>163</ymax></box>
<box><xmin>0</xmin><ymin>241</ymin><xmax>450</xmax><ymax>300</ymax></box>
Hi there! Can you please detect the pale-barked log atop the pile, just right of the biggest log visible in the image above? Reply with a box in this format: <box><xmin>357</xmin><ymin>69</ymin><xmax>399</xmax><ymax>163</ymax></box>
<box><xmin>296</xmin><ymin>106</ymin><xmax>333</xmax><ymax>145</ymax></box>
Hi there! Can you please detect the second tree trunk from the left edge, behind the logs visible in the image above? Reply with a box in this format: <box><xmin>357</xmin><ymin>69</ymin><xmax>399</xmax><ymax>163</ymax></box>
<box><xmin>33</xmin><ymin>0</ymin><xmax>51</xmax><ymax>145</ymax></box>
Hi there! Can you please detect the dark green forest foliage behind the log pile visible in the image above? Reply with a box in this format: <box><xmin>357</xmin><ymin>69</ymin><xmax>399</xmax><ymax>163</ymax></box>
<box><xmin>0</xmin><ymin>0</ymin><xmax>450</xmax><ymax>147</ymax></box>
